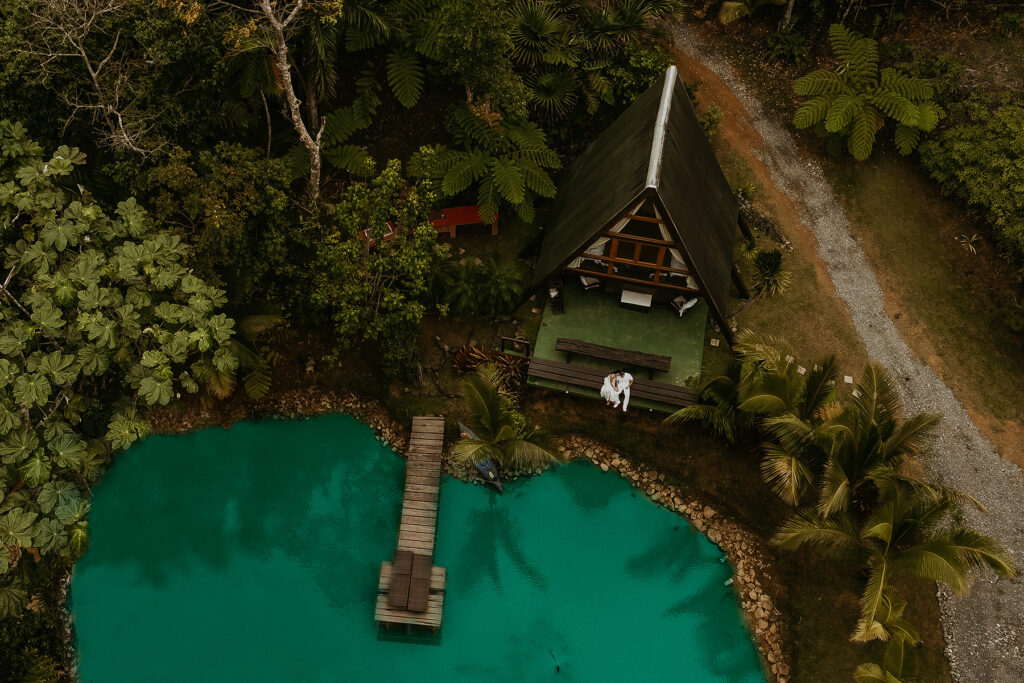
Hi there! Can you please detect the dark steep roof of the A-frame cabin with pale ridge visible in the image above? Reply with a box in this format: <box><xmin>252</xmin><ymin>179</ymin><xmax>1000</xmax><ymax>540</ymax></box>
<box><xmin>534</xmin><ymin>67</ymin><xmax>738</xmax><ymax>325</ymax></box>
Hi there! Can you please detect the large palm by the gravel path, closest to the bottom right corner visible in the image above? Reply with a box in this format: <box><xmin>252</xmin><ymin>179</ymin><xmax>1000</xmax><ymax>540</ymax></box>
<box><xmin>773</xmin><ymin>476</ymin><xmax>1016</xmax><ymax>641</ymax></box>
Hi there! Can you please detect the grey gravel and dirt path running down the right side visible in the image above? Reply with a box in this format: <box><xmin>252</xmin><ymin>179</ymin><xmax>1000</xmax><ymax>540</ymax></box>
<box><xmin>674</xmin><ymin>25</ymin><xmax>1024</xmax><ymax>683</ymax></box>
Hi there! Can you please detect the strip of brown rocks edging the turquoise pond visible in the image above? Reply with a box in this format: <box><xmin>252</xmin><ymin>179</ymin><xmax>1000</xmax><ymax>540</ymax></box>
<box><xmin>142</xmin><ymin>390</ymin><xmax>791</xmax><ymax>683</ymax></box>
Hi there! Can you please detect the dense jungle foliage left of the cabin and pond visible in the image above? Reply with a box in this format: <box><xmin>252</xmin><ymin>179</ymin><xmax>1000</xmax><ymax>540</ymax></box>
<box><xmin>0</xmin><ymin>0</ymin><xmax>692</xmax><ymax>680</ymax></box>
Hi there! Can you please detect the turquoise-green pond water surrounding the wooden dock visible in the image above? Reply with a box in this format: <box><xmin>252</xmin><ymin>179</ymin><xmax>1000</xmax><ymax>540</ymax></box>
<box><xmin>72</xmin><ymin>416</ymin><xmax>763</xmax><ymax>683</ymax></box>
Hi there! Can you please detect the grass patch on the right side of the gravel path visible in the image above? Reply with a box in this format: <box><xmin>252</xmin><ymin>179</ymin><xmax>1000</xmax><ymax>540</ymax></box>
<box><xmin>826</xmin><ymin>154</ymin><xmax>1024</xmax><ymax>464</ymax></box>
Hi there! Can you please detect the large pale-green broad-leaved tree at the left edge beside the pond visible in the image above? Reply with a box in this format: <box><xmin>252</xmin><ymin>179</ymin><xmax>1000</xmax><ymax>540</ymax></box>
<box><xmin>0</xmin><ymin>121</ymin><xmax>238</xmax><ymax>616</ymax></box>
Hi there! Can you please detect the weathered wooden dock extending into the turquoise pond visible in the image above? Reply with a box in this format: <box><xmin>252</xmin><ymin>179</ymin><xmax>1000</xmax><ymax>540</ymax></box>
<box><xmin>374</xmin><ymin>416</ymin><xmax>446</xmax><ymax>631</ymax></box>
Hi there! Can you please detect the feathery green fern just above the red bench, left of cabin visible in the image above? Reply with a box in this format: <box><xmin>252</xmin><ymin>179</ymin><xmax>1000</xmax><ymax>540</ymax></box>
<box><xmin>417</xmin><ymin>106</ymin><xmax>561</xmax><ymax>222</ymax></box>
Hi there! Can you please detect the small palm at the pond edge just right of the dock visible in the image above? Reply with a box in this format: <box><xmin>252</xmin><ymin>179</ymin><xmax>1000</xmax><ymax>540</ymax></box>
<box><xmin>454</xmin><ymin>367</ymin><xmax>560</xmax><ymax>470</ymax></box>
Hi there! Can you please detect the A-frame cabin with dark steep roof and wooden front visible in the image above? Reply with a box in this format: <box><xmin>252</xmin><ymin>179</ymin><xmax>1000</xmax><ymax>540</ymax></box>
<box><xmin>534</xmin><ymin>67</ymin><xmax>748</xmax><ymax>343</ymax></box>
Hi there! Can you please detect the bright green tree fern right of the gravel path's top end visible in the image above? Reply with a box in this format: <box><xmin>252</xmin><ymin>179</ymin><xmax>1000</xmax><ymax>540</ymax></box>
<box><xmin>793</xmin><ymin>24</ymin><xmax>943</xmax><ymax>161</ymax></box>
